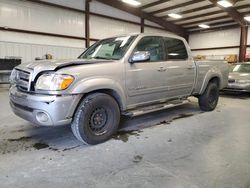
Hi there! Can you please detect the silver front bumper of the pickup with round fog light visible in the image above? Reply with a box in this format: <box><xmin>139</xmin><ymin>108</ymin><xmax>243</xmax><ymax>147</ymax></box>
<box><xmin>10</xmin><ymin>86</ymin><xmax>82</xmax><ymax>126</ymax></box>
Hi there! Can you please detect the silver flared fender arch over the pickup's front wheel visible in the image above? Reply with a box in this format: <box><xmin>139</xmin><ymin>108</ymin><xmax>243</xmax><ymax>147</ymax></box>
<box><xmin>72</xmin><ymin>77</ymin><xmax>126</xmax><ymax>110</ymax></box>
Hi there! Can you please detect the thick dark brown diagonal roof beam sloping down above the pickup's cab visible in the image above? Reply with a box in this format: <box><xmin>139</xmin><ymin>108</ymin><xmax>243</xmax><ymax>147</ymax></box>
<box><xmin>96</xmin><ymin>0</ymin><xmax>187</xmax><ymax>36</ymax></box>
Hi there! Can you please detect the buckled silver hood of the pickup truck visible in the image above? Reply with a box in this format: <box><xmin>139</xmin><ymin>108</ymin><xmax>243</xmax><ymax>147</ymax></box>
<box><xmin>18</xmin><ymin>59</ymin><xmax>112</xmax><ymax>74</ymax></box>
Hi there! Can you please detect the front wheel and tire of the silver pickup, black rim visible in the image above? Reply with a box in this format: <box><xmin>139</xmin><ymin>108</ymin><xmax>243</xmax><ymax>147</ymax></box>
<box><xmin>71</xmin><ymin>93</ymin><xmax>120</xmax><ymax>145</ymax></box>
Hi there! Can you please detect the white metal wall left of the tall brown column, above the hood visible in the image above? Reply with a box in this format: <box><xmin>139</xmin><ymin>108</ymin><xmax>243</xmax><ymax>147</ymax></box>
<box><xmin>0</xmin><ymin>0</ymin><xmax>85</xmax><ymax>62</ymax></box>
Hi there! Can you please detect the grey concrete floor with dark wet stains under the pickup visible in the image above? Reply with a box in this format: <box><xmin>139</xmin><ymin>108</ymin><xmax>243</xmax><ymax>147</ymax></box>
<box><xmin>0</xmin><ymin>89</ymin><xmax>250</xmax><ymax>188</ymax></box>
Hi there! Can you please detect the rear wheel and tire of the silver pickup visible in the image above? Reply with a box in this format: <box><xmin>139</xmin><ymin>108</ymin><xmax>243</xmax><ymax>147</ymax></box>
<box><xmin>199</xmin><ymin>82</ymin><xmax>219</xmax><ymax>111</ymax></box>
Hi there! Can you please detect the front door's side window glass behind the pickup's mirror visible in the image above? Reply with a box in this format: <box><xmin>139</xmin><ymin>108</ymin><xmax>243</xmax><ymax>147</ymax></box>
<box><xmin>134</xmin><ymin>36</ymin><xmax>164</xmax><ymax>62</ymax></box>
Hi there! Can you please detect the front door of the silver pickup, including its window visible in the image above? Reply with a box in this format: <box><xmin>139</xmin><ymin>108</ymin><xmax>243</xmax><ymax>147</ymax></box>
<box><xmin>126</xmin><ymin>36</ymin><xmax>168</xmax><ymax>106</ymax></box>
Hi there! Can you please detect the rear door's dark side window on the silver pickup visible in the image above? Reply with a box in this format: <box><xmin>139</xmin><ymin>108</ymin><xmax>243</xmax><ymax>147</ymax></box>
<box><xmin>164</xmin><ymin>37</ymin><xmax>188</xmax><ymax>60</ymax></box>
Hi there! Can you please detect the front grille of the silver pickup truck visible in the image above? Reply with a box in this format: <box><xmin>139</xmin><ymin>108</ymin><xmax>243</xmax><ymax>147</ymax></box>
<box><xmin>15</xmin><ymin>69</ymin><xmax>30</xmax><ymax>91</ymax></box>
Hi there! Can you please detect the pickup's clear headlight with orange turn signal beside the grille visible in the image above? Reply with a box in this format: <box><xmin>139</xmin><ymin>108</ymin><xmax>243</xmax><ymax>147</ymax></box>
<box><xmin>35</xmin><ymin>73</ymin><xmax>74</xmax><ymax>91</ymax></box>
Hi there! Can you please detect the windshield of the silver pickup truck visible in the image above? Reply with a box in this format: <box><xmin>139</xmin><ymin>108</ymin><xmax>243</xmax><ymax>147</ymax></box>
<box><xmin>79</xmin><ymin>36</ymin><xmax>136</xmax><ymax>60</ymax></box>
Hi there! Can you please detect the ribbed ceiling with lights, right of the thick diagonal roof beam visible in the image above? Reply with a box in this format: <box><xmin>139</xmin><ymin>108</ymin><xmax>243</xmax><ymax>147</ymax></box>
<box><xmin>140</xmin><ymin>0</ymin><xmax>250</xmax><ymax>32</ymax></box>
